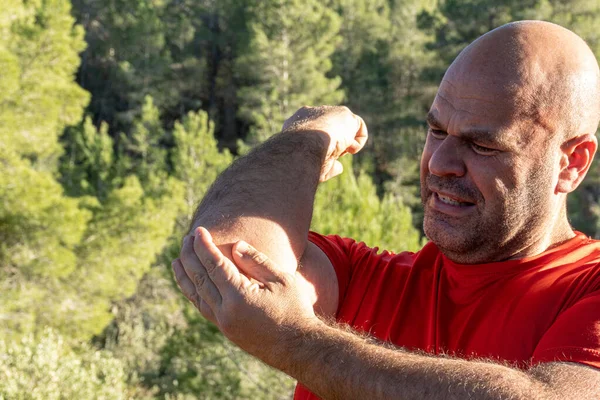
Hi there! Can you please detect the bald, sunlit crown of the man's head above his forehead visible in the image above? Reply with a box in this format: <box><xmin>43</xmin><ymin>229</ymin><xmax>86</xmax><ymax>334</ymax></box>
<box><xmin>444</xmin><ymin>21</ymin><xmax>600</xmax><ymax>140</ymax></box>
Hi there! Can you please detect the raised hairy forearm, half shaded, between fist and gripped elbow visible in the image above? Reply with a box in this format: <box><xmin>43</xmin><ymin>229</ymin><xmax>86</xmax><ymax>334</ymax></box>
<box><xmin>191</xmin><ymin>131</ymin><xmax>327</xmax><ymax>270</ymax></box>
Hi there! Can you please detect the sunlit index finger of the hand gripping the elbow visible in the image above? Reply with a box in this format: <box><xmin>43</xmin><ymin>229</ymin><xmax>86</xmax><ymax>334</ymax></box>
<box><xmin>193</xmin><ymin>227</ymin><xmax>241</xmax><ymax>292</ymax></box>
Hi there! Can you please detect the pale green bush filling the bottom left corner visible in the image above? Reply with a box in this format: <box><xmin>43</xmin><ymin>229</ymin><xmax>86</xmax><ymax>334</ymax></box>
<box><xmin>0</xmin><ymin>329</ymin><xmax>129</xmax><ymax>400</ymax></box>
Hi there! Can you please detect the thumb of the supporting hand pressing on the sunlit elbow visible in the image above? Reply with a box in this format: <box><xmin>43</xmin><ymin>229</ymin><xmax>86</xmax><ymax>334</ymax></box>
<box><xmin>233</xmin><ymin>240</ymin><xmax>284</xmax><ymax>287</ymax></box>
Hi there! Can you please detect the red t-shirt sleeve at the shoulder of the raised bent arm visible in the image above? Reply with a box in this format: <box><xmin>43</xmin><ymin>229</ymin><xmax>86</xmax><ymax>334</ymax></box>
<box><xmin>308</xmin><ymin>232</ymin><xmax>372</xmax><ymax>310</ymax></box>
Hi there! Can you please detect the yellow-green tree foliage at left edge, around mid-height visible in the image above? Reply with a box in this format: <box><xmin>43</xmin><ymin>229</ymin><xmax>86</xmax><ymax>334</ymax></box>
<box><xmin>0</xmin><ymin>146</ymin><xmax>90</xmax><ymax>278</ymax></box>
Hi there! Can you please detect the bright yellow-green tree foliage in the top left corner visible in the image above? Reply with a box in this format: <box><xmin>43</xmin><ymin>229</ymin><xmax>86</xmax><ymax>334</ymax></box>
<box><xmin>0</xmin><ymin>0</ymin><xmax>88</xmax><ymax>164</ymax></box>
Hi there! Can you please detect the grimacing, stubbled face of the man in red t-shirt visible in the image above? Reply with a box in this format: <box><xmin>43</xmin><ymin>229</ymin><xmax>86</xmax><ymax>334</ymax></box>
<box><xmin>421</xmin><ymin>73</ymin><xmax>558</xmax><ymax>264</ymax></box>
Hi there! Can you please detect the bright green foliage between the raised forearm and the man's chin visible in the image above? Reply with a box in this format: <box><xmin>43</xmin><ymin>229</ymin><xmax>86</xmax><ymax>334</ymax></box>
<box><xmin>311</xmin><ymin>157</ymin><xmax>421</xmax><ymax>252</ymax></box>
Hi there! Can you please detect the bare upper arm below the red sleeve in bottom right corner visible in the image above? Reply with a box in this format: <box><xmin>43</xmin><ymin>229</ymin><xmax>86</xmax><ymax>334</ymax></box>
<box><xmin>529</xmin><ymin>362</ymin><xmax>600</xmax><ymax>400</ymax></box>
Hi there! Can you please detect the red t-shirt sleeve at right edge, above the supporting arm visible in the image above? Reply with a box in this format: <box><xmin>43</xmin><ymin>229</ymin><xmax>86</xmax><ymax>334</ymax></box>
<box><xmin>532</xmin><ymin>292</ymin><xmax>600</xmax><ymax>369</ymax></box>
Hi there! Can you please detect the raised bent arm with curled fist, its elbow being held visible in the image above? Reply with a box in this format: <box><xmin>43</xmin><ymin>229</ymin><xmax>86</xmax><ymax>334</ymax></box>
<box><xmin>188</xmin><ymin>106</ymin><xmax>368</xmax><ymax>316</ymax></box>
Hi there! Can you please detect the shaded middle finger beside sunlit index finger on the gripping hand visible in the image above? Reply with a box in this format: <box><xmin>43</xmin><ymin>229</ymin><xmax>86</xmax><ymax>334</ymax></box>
<box><xmin>179</xmin><ymin>236</ymin><xmax>223</xmax><ymax>310</ymax></box>
